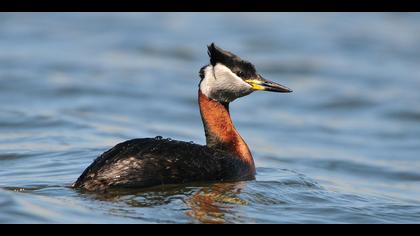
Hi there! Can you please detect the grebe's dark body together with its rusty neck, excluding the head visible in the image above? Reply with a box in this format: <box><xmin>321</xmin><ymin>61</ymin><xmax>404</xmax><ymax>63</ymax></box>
<box><xmin>73</xmin><ymin>89</ymin><xmax>255</xmax><ymax>191</ymax></box>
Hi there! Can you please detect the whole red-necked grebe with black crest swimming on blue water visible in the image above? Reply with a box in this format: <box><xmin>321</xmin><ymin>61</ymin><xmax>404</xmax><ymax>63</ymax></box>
<box><xmin>73</xmin><ymin>43</ymin><xmax>292</xmax><ymax>191</ymax></box>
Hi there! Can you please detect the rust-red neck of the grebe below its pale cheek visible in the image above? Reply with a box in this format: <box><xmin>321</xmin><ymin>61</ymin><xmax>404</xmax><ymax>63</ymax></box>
<box><xmin>198</xmin><ymin>90</ymin><xmax>255</xmax><ymax>174</ymax></box>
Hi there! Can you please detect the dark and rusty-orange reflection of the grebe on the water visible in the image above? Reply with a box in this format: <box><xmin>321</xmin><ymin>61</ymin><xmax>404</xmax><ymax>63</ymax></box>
<box><xmin>80</xmin><ymin>182</ymin><xmax>247</xmax><ymax>224</ymax></box>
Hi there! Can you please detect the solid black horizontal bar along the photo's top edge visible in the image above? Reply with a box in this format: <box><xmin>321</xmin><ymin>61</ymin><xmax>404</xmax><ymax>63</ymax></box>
<box><xmin>0</xmin><ymin>0</ymin><xmax>420</xmax><ymax>12</ymax></box>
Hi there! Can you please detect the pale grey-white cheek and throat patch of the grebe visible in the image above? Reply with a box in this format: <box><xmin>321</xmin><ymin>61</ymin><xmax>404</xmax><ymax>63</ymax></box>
<box><xmin>200</xmin><ymin>64</ymin><xmax>252</xmax><ymax>102</ymax></box>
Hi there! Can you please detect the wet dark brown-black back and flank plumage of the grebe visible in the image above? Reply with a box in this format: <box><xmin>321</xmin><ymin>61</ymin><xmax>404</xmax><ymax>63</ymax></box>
<box><xmin>74</xmin><ymin>138</ymin><xmax>253</xmax><ymax>190</ymax></box>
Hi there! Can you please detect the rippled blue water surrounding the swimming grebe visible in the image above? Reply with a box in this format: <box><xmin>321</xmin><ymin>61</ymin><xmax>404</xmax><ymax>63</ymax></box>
<box><xmin>0</xmin><ymin>13</ymin><xmax>420</xmax><ymax>223</ymax></box>
